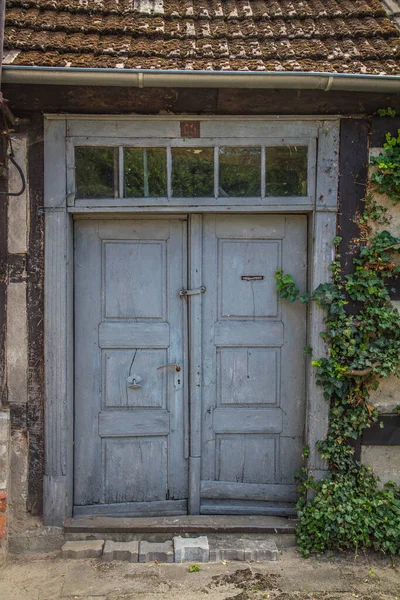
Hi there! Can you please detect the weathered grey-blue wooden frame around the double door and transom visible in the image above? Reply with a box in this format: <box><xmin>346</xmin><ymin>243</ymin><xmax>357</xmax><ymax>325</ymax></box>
<box><xmin>44</xmin><ymin>115</ymin><xmax>340</xmax><ymax>526</ymax></box>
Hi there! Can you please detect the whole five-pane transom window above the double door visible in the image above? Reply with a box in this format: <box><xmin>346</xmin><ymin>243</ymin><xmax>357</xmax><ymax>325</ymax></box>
<box><xmin>74</xmin><ymin>140</ymin><xmax>312</xmax><ymax>200</ymax></box>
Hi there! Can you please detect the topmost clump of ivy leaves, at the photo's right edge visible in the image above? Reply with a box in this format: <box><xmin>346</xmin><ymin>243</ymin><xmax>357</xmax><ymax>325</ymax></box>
<box><xmin>371</xmin><ymin>129</ymin><xmax>400</xmax><ymax>204</ymax></box>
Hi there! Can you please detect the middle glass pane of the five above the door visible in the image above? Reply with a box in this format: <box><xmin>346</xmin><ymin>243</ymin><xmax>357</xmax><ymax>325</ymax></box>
<box><xmin>172</xmin><ymin>148</ymin><xmax>214</xmax><ymax>198</ymax></box>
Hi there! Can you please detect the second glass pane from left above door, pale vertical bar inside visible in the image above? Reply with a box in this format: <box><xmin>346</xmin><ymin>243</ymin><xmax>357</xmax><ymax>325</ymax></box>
<box><xmin>124</xmin><ymin>148</ymin><xmax>167</xmax><ymax>198</ymax></box>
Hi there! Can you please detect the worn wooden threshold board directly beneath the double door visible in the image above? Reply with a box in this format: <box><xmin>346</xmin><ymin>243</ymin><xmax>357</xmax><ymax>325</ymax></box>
<box><xmin>64</xmin><ymin>515</ymin><xmax>297</xmax><ymax>535</ymax></box>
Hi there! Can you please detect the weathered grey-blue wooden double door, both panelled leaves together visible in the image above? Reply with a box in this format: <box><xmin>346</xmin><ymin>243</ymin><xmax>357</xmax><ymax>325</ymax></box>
<box><xmin>74</xmin><ymin>215</ymin><xmax>307</xmax><ymax>516</ymax></box>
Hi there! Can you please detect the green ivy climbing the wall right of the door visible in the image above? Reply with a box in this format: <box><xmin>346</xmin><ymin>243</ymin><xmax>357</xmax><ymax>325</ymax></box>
<box><xmin>276</xmin><ymin>123</ymin><xmax>400</xmax><ymax>556</ymax></box>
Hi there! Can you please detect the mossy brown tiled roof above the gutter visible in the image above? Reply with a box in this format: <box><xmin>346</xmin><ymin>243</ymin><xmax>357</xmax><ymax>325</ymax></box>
<box><xmin>5</xmin><ymin>0</ymin><xmax>400</xmax><ymax>75</ymax></box>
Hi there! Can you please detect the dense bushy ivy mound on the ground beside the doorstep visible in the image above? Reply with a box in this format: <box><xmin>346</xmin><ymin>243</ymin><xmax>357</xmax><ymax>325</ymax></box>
<box><xmin>297</xmin><ymin>466</ymin><xmax>400</xmax><ymax>556</ymax></box>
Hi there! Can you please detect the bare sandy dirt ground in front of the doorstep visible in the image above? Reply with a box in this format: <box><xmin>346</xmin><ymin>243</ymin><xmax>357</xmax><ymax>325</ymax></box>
<box><xmin>0</xmin><ymin>548</ymin><xmax>400</xmax><ymax>600</ymax></box>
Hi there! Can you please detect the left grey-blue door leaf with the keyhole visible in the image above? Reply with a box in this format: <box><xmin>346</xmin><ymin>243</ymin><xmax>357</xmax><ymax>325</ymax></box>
<box><xmin>74</xmin><ymin>219</ymin><xmax>188</xmax><ymax>516</ymax></box>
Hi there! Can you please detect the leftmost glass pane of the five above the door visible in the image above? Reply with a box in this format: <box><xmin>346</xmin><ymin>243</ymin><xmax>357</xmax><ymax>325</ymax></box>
<box><xmin>75</xmin><ymin>148</ymin><xmax>118</xmax><ymax>198</ymax></box>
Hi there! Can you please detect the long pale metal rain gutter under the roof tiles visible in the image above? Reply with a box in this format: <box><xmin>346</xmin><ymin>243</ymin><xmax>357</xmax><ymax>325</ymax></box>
<box><xmin>3</xmin><ymin>65</ymin><xmax>400</xmax><ymax>94</ymax></box>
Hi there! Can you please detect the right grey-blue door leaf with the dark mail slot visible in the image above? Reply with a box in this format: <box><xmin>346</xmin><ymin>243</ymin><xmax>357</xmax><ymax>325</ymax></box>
<box><xmin>201</xmin><ymin>215</ymin><xmax>307</xmax><ymax>514</ymax></box>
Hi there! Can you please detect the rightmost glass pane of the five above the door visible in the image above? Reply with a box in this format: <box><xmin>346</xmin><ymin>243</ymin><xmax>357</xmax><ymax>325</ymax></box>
<box><xmin>265</xmin><ymin>146</ymin><xmax>308</xmax><ymax>196</ymax></box>
